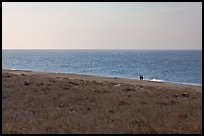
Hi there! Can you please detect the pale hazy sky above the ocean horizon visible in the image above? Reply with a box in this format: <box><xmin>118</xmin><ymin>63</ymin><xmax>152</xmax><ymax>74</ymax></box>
<box><xmin>2</xmin><ymin>2</ymin><xmax>202</xmax><ymax>49</ymax></box>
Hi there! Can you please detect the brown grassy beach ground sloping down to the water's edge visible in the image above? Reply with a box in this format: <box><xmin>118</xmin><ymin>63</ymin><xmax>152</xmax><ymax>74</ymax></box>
<box><xmin>2</xmin><ymin>70</ymin><xmax>202</xmax><ymax>134</ymax></box>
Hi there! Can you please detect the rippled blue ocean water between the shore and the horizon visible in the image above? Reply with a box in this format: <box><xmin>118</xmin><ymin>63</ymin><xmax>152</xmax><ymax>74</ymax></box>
<box><xmin>2</xmin><ymin>50</ymin><xmax>202</xmax><ymax>85</ymax></box>
